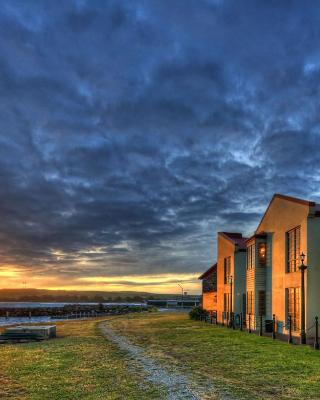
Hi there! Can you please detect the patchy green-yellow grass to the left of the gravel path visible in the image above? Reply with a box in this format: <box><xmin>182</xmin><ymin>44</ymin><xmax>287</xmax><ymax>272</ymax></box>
<box><xmin>0</xmin><ymin>320</ymin><xmax>161</xmax><ymax>400</ymax></box>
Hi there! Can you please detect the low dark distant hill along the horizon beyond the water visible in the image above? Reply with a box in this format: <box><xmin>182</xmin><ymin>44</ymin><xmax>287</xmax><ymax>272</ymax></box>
<box><xmin>0</xmin><ymin>289</ymin><xmax>195</xmax><ymax>303</ymax></box>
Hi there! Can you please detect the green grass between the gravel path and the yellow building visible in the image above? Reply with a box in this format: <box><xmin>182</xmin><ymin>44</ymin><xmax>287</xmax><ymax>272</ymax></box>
<box><xmin>111</xmin><ymin>313</ymin><xmax>320</xmax><ymax>399</ymax></box>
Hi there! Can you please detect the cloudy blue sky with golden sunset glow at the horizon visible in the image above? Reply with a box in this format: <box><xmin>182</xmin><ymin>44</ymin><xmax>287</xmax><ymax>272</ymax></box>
<box><xmin>0</xmin><ymin>0</ymin><xmax>320</xmax><ymax>293</ymax></box>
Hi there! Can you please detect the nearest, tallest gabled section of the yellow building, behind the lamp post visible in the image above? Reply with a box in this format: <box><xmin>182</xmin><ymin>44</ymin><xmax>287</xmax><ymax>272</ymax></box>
<box><xmin>251</xmin><ymin>194</ymin><xmax>320</xmax><ymax>336</ymax></box>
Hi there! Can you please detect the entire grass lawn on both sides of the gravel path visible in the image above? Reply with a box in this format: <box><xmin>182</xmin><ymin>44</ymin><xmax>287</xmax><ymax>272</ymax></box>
<box><xmin>0</xmin><ymin>313</ymin><xmax>320</xmax><ymax>400</ymax></box>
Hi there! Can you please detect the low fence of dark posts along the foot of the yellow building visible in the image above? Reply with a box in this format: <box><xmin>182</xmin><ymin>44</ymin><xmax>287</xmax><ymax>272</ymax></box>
<box><xmin>199</xmin><ymin>311</ymin><xmax>319</xmax><ymax>350</ymax></box>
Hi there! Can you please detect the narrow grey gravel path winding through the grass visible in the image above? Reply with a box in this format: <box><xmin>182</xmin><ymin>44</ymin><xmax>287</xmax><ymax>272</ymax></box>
<box><xmin>99</xmin><ymin>322</ymin><xmax>230</xmax><ymax>400</ymax></box>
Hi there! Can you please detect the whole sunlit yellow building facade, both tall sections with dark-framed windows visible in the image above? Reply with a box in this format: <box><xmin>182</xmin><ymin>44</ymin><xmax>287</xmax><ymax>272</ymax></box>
<box><xmin>200</xmin><ymin>194</ymin><xmax>320</xmax><ymax>336</ymax></box>
